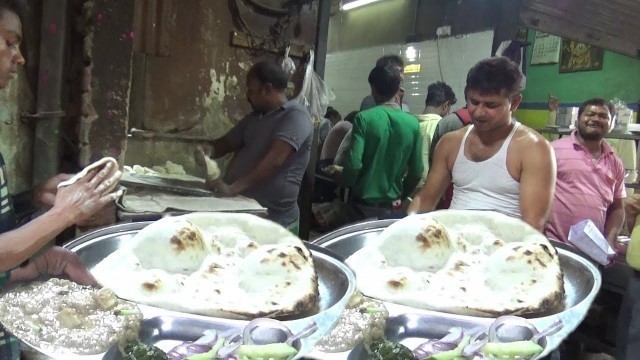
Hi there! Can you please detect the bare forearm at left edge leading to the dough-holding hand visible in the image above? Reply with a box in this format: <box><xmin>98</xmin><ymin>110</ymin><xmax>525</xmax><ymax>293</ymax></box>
<box><xmin>0</xmin><ymin>209</ymin><xmax>73</xmax><ymax>272</ymax></box>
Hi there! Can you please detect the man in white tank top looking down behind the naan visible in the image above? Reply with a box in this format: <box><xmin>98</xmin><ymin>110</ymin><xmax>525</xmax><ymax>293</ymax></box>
<box><xmin>408</xmin><ymin>58</ymin><xmax>556</xmax><ymax>231</ymax></box>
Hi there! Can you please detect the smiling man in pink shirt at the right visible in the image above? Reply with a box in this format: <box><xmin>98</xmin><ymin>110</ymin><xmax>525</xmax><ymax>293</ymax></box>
<box><xmin>545</xmin><ymin>99</ymin><xmax>626</xmax><ymax>249</ymax></box>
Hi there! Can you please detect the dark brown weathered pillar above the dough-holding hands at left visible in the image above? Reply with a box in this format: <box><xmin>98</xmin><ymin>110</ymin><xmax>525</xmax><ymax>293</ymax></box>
<box><xmin>80</xmin><ymin>0</ymin><xmax>135</xmax><ymax>165</ymax></box>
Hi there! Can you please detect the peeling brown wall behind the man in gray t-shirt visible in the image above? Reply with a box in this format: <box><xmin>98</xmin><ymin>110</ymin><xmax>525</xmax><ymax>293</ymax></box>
<box><xmin>125</xmin><ymin>0</ymin><xmax>317</xmax><ymax>173</ymax></box>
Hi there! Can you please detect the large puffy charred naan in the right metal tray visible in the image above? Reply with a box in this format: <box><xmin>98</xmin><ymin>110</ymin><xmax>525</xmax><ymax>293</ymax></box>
<box><xmin>347</xmin><ymin>210</ymin><xmax>564</xmax><ymax>317</ymax></box>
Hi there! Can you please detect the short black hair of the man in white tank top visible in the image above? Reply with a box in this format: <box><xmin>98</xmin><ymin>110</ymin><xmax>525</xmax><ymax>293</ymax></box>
<box><xmin>467</xmin><ymin>57</ymin><xmax>522</xmax><ymax>97</ymax></box>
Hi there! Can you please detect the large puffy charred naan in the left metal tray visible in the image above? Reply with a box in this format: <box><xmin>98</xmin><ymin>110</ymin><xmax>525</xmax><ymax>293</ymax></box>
<box><xmin>91</xmin><ymin>213</ymin><xmax>318</xmax><ymax>319</ymax></box>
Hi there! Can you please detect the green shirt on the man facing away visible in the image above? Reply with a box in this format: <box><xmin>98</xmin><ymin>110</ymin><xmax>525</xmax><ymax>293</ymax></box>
<box><xmin>342</xmin><ymin>105</ymin><xmax>423</xmax><ymax>202</ymax></box>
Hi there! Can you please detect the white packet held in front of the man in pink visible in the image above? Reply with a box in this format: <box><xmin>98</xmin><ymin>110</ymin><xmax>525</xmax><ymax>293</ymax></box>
<box><xmin>569</xmin><ymin>220</ymin><xmax>616</xmax><ymax>266</ymax></box>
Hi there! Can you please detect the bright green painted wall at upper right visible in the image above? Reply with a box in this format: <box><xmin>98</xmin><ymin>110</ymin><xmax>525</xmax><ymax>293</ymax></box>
<box><xmin>523</xmin><ymin>30</ymin><xmax>640</xmax><ymax>104</ymax></box>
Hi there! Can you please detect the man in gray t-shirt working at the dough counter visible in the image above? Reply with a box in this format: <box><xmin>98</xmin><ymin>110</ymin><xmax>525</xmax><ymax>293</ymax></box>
<box><xmin>204</xmin><ymin>62</ymin><xmax>313</xmax><ymax>233</ymax></box>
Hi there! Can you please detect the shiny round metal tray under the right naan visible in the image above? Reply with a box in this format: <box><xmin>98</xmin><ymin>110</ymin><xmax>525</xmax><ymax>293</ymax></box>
<box><xmin>312</xmin><ymin>219</ymin><xmax>602</xmax><ymax>359</ymax></box>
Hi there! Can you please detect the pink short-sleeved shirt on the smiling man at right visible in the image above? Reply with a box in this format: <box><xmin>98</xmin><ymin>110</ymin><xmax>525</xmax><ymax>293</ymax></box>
<box><xmin>545</xmin><ymin>131</ymin><xmax>626</xmax><ymax>242</ymax></box>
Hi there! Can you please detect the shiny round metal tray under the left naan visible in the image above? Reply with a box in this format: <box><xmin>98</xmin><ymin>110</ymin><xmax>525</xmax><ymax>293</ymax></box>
<box><xmin>18</xmin><ymin>222</ymin><xmax>355</xmax><ymax>360</ymax></box>
